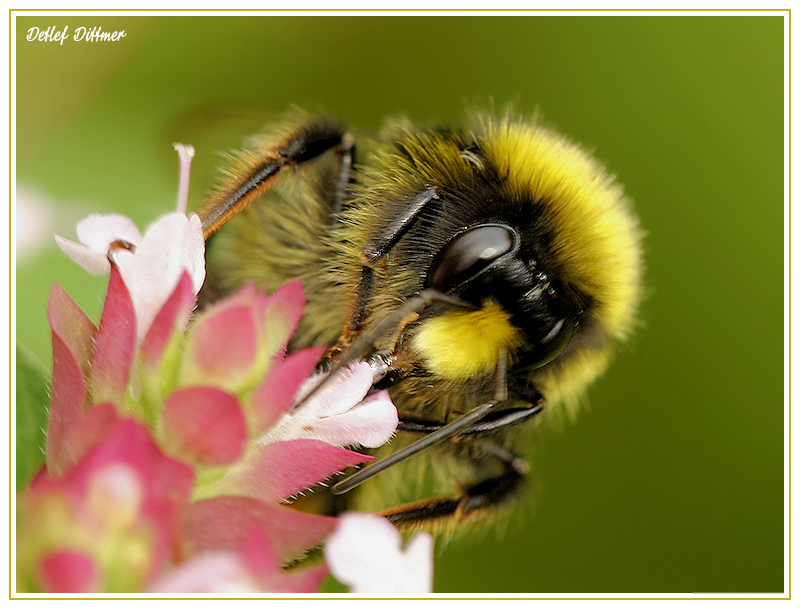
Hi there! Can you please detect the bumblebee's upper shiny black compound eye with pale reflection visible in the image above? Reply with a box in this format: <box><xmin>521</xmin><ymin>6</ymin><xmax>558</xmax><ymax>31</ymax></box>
<box><xmin>425</xmin><ymin>224</ymin><xmax>517</xmax><ymax>292</ymax></box>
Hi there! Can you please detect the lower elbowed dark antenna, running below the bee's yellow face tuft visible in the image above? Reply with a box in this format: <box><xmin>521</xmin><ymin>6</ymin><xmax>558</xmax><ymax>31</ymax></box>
<box><xmin>331</xmin><ymin>349</ymin><xmax>508</xmax><ymax>495</ymax></box>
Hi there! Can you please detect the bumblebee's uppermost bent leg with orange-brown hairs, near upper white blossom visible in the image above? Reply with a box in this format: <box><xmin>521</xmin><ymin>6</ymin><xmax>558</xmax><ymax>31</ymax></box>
<box><xmin>198</xmin><ymin>119</ymin><xmax>353</xmax><ymax>239</ymax></box>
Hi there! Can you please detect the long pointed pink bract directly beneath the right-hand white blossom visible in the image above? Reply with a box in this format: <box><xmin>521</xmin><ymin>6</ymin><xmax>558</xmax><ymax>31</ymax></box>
<box><xmin>207</xmin><ymin>440</ymin><xmax>374</xmax><ymax>502</ymax></box>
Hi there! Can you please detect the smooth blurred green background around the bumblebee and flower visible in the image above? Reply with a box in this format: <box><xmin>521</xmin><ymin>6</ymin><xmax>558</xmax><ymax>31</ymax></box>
<box><xmin>16</xmin><ymin>15</ymin><xmax>788</xmax><ymax>593</ymax></box>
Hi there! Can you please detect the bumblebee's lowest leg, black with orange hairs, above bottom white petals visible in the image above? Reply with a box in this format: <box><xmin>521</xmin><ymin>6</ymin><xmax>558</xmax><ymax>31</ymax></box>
<box><xmin>378</xmin><ymin>443</ymin><xmax>528</xmax><ymax>528</ymax></box>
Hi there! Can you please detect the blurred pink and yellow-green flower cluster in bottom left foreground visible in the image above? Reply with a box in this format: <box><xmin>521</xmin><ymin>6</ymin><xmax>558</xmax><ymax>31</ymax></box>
<box><xmin>17</xmin><ymin>419</ymin><xmax>194</xmax><ymax>592</ymax></box>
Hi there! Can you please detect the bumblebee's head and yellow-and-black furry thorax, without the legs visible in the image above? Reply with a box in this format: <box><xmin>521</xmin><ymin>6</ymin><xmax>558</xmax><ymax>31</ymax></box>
<box><xmin>346</xmin><ymin>114</ymin><xmax>642</xmax><ymax>410</ymax></box>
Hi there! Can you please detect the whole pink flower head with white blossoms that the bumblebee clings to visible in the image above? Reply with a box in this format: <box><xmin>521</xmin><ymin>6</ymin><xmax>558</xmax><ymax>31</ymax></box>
<box><xmin>24</xmin><ymin>140</ymin><xmax>416</xmax><ymax>592</ymax></box>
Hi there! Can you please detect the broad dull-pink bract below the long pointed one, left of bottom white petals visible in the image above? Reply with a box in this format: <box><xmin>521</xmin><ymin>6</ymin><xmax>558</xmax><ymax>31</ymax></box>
<box><xmin>180</xmin><ymin>495</ymin><xmax>337</xmax><ymax>560</ymax></box>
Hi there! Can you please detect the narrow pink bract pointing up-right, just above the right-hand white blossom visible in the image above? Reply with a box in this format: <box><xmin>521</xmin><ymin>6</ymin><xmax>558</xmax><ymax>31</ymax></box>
<box><xmin>250</xmin><ymin>347</ymin><xmax>325</xmax><ymax>434</ymax></box>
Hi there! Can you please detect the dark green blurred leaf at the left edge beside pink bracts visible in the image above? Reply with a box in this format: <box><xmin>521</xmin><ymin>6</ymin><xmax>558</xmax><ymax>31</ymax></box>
<box><xmin>17</xmin><ymin>345</ymin><xmax>50</xmax><ymax>491</ymax></box>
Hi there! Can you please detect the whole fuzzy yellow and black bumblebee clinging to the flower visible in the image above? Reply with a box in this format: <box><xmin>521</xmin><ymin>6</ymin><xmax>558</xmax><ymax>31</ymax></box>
<box><xmin>199</xmin><ymin>107</ymin><xmax>642</xmax><ymax>530</ymax></box>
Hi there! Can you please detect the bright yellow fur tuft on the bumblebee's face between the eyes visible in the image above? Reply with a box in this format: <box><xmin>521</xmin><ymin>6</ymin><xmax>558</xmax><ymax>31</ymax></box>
<box><xmin>413</xmin><ymin>301</ymin><xmax>522</xmax><ymax>381</ymax></box>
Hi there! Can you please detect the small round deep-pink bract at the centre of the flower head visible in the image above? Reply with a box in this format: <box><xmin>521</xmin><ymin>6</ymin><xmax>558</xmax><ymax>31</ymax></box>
<box><xmin>161</xmin><ymin>387</ymin><xmax>247</xmax><ymax>466</ymax></box>
